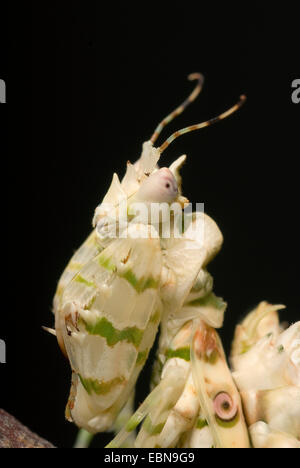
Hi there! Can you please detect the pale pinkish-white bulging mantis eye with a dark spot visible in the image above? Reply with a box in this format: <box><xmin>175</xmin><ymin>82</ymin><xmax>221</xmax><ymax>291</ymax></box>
<box><xmin>138</xmin><ymin>167</ymin><xmax>178</xmax><ymax>203</ymax></box>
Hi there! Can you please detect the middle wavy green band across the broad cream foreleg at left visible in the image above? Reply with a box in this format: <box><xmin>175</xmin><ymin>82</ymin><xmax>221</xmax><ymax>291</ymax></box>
<box><xmin>80</xmin><ymin>317</ymin><xmax>144</xmax><ymax>347</ymax></box>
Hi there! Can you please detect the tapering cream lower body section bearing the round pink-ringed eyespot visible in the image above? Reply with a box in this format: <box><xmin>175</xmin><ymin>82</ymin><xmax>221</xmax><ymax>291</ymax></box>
<box><xmin>109</xmin><ymin>312</ymin><xmax>249</xmax><ymax>448</ymax></box>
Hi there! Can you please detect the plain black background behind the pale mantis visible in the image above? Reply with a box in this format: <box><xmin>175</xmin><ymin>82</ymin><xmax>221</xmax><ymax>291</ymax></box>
<box><xmin>0</xmin><ymin>1</ymin><xmax>300</xmax><ymax>447</ymax></box>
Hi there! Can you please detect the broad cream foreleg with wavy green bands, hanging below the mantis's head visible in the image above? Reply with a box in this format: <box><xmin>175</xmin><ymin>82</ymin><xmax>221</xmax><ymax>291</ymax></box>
<box><xmin>56</xmin><ymin>232</ymin><xmax>162</xmax><ymax>432</ymax></box>
